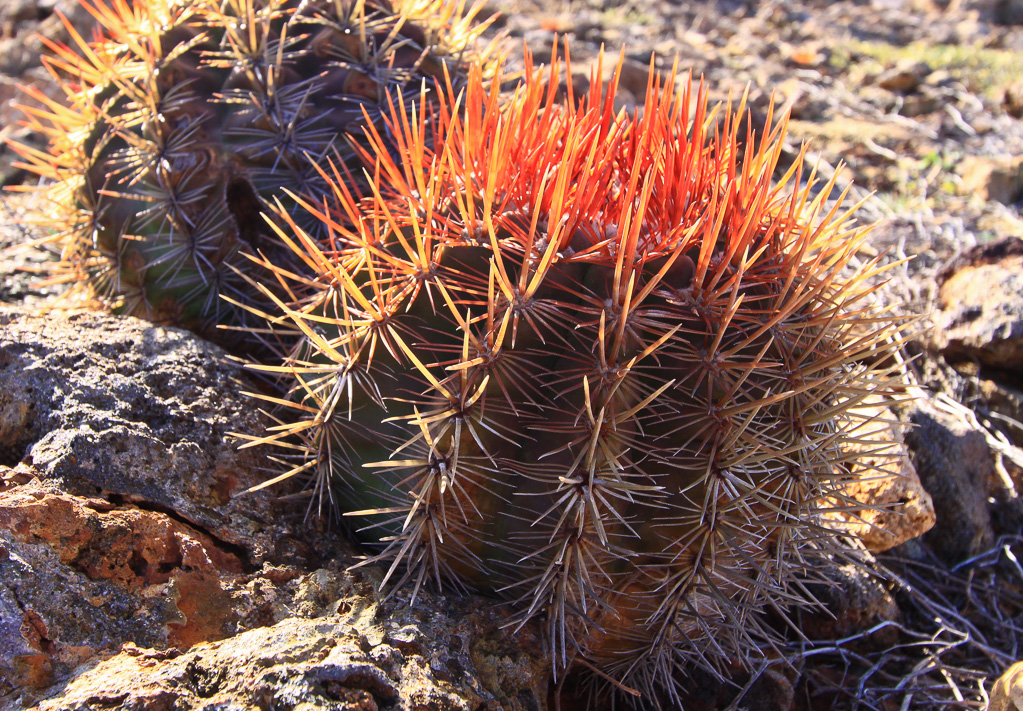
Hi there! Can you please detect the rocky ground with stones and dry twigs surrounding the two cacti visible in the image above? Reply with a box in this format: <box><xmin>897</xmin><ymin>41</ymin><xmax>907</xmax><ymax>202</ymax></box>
<box><xmin>0</xmin><ymin>0</ymin><xmax>1023</xmax><ymax>711</ymax></box>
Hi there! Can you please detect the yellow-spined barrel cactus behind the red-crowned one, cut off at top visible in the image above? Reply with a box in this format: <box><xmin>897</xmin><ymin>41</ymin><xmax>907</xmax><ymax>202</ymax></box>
<box><xmin>6</xmin><ymin>0</ymin><xmax>501</xmax><ymax>341</ymax></box>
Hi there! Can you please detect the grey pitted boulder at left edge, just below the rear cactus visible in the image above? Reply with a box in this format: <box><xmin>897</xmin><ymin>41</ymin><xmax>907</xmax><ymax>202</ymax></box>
<box><xmin>0</xmin><ymin>310</ymin><xmax>307</xmax><ymax>566</ymax></box>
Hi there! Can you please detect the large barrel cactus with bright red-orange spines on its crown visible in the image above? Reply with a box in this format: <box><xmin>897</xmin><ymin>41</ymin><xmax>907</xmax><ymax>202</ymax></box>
<box><xmin>249</xmin><ymin>51</ymin><xmax>912</xmax><ymax>697</ymax></box>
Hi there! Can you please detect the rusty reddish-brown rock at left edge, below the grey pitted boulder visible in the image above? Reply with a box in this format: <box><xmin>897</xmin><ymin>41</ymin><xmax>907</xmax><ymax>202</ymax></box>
<box><xmin>0</xmin><ymin>472</ymin><xmax>245</xmax><ymax>694</ymax></box>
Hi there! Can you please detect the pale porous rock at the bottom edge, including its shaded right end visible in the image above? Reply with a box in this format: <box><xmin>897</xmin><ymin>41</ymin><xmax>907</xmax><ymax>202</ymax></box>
<box><xmin>28</xmin><ymin>571</ymin><xmax>547</xmax><ymax>711</ymax></box>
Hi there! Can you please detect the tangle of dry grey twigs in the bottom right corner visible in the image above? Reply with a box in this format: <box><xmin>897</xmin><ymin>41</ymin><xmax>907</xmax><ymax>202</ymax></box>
<box><xmin>798</xmin><ymin>535</ymin><xmax>1023</xmax><ymax>711</ymax></box>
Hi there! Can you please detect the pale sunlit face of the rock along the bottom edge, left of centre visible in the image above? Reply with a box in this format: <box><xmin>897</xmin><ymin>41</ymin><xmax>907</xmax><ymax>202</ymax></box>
<box><xmin>29</xmin><ymin>611</ymin><xmax>546</xmax><ymax>711</ymax></box>
